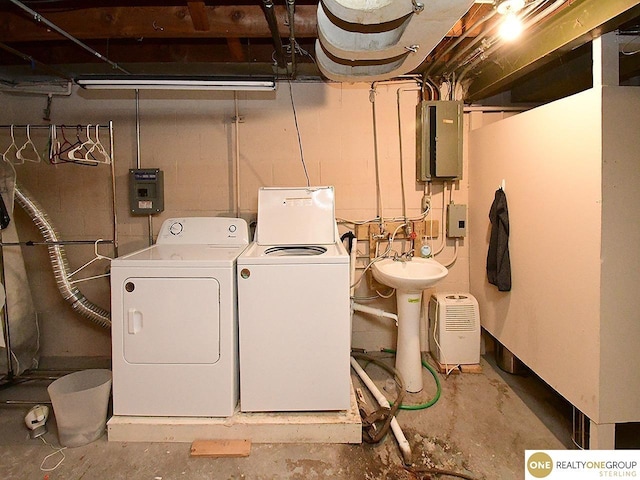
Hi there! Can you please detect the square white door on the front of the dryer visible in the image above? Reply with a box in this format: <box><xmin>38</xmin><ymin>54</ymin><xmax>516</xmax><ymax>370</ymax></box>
<box><xmin>122</xmin><ymin>277</ymin><xmax>220</xmax><ymax>364</ymax></box>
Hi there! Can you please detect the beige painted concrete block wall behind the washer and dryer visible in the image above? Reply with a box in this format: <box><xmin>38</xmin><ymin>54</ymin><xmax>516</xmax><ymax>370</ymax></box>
<box><xmin>0</xmin><ymin>82</ymin><xmax>469</xmax><ymax>356</ymax></box>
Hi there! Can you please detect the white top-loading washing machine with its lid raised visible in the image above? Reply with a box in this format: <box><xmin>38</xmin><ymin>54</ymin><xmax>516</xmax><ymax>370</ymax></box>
<box><xmin>238</xmin><ymin>187</ymin><xmax>351</xmax><ymax>412</ymax></box>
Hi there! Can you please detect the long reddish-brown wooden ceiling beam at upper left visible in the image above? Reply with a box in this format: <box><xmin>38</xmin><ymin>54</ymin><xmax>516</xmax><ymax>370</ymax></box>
<box><xmin>0</xmin><ymin>2</ymin><xmax>317</xmax><ymax>43</ymax></box>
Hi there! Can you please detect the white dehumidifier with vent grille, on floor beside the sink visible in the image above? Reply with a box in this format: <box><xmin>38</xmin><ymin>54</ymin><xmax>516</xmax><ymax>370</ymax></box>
<box><xmin>429</xmin><ymin>293</ymin><xmax>480</xmax><ymax>365</ymax></box>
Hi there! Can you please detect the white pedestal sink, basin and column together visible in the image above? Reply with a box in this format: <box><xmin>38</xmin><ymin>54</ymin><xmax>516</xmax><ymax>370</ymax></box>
<box><xmin>371</xmin><ymin>258</ymin><xmax>449</xmax><ymax>393</ymax></box>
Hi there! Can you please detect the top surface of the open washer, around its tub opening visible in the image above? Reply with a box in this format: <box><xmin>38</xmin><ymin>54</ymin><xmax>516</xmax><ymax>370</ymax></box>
<box><xmin>238</xmin><ymin>242</ymin><xmax>349</xmax><ymax>265</ymax></box>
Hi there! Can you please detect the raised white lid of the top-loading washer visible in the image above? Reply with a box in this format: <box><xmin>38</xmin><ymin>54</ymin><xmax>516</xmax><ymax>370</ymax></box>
<box><xmin>256</xmin><ymin>187</ymin><xmax>337</xmax><ymax>245</ymax></box>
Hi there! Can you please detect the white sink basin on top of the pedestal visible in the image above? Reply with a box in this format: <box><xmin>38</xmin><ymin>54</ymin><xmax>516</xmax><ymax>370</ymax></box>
<box><xmin>372</xmin><ymin>257</ymin><xmax>449</xmax><ymax>293</ymax></box>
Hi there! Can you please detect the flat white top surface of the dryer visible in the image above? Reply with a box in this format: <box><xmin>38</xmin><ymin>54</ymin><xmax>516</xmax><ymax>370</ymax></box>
<box><xmin>111</xmin><ymin>244</ymin><xmax>246</xmax><ymax>268</ymax></box>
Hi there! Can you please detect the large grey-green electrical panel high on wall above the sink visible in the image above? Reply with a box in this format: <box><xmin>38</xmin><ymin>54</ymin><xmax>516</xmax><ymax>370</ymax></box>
<box><xmin>416</xmin><ymin>101</ymin><xmax>463</xmax><ymax>182</ymax></box>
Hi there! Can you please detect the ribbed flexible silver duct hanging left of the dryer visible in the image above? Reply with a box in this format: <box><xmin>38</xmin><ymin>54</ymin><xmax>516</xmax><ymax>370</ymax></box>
<box><xmin>15</xmin><ymin>183</ymin><xmax>111</xmax><ymax>328</ymax></box>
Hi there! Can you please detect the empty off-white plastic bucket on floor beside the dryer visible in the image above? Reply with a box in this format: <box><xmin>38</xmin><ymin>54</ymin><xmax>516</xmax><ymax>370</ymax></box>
<box><xmin>47</xmin><ymin>369</ymin><xmax>111</xmax><ymax>447</ymax></box>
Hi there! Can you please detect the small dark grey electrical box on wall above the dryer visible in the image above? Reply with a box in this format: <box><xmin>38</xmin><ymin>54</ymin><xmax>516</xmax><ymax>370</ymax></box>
<box><xmin>129</xmin><ymin>168</ymin><xmax>164</xmax><ymax>215</ymax></box>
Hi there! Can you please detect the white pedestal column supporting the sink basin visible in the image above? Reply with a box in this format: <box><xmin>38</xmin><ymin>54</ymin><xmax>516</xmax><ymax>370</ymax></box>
<box><xmin>396</xmin><ymin>290</ymin><xmax>422</xmax><ymax>393</ymax></box>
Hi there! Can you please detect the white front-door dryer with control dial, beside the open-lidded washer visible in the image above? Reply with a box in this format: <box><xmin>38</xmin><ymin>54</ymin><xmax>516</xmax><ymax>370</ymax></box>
<box><xmin>111</xmin><ymin>217</ymin><xmax>249</xmax><ymax>417</ymax></box>
